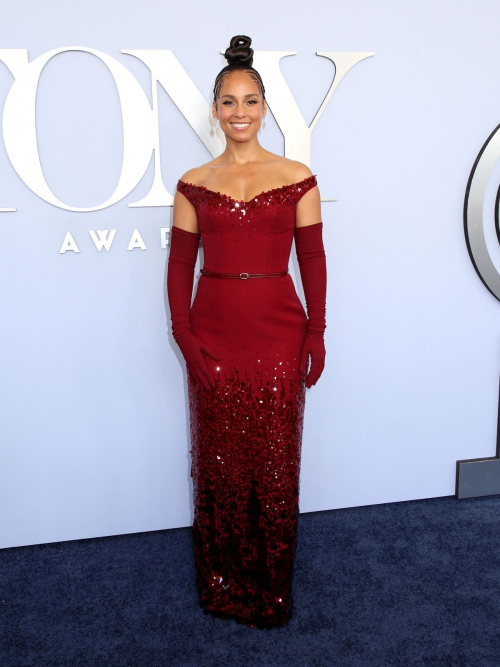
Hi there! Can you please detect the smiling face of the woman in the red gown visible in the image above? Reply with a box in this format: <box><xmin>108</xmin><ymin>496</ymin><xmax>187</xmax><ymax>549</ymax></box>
<box><xmin>213</xmin><ymin>71</ymin><xmax>266</xmax><ymax>142</ymax></box>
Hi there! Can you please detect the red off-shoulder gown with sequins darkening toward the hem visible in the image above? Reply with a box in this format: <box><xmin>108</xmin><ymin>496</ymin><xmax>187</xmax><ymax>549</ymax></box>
<box><xmin>177</xmin><ymin>176</ymin><xmax>317</xmax><ymax>628</ymax></box>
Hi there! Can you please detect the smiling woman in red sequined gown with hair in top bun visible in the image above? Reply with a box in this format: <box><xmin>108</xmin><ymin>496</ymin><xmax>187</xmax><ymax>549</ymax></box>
<box><xmin>167</xmin><ymin>35</ymin><xmax>326</xmax><ymax>628</ymax></box>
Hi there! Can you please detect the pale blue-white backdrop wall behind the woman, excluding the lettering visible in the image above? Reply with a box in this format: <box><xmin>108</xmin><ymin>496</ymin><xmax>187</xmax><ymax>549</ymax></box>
<box><xmin>0</xmin><ymin>0</ymin><xmax>500</xmax><ymax>547</ymax></box>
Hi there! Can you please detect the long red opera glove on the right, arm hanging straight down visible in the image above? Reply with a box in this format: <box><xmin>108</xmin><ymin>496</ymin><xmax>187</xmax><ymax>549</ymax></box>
<box><xmin>294</xmin><ymin>222</ymin><xmax>326</xmax><ymax>389</ymax></box>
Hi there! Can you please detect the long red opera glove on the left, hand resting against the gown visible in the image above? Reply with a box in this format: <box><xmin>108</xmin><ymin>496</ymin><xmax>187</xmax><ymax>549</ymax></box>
<box><xmin>167</xmin><ymin>227</ymin><xmax>222</xmax><ymax>389</ymax></box>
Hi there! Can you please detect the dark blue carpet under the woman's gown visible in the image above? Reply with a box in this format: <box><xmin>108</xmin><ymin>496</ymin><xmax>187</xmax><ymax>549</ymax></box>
<box><xmin>0</xmin><ymin>496</ymin><xmax>500</xmax><ymax>667</ymax></box>
